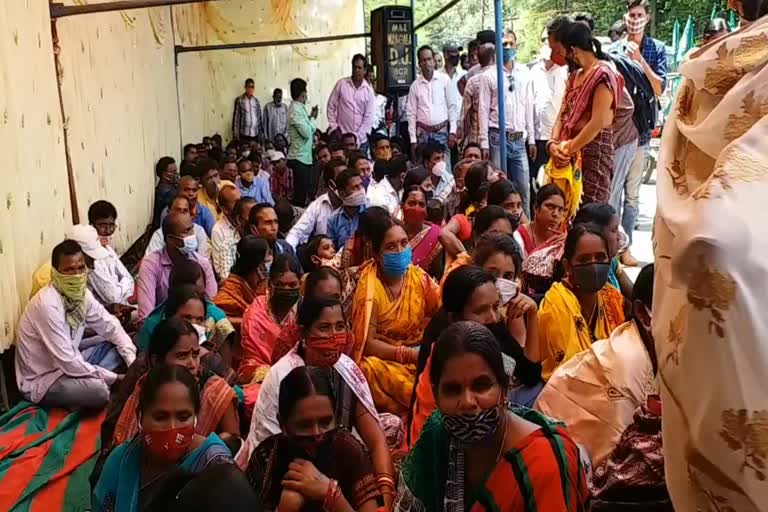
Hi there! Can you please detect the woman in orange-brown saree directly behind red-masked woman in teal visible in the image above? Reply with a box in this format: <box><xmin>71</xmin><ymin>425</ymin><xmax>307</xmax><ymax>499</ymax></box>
<box><xmin>112</xmin><ymin>318</ymin><xmax>240</xmax><ymax>445</ymax></box>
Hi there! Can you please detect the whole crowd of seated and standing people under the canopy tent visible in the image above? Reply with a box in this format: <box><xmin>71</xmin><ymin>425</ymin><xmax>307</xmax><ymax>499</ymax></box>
<box><xmin>6</xmin><ymin>0</ymin><xmax>762</xmax><ymax>512</ymax></box>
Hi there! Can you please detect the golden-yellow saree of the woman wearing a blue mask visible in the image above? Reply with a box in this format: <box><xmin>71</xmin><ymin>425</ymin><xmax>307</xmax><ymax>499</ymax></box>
<box><xmin>352</xmin><ymin>262</ymin><xmax>440</xmax><ymax>415</ymax></box>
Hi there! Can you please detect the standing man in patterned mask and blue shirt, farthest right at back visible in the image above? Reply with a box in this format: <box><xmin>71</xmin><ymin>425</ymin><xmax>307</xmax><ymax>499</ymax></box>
<box><xmin>621</xmin><ymin>0</ymin><xmax>667</xmax><ymax>267</ymax></box>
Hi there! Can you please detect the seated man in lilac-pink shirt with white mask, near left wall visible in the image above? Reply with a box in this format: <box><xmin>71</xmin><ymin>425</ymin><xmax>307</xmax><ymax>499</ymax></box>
<box><xmin>138</xmin><ymin>212</ymin><xmax>218</xmax><ymax>320</ymax></box>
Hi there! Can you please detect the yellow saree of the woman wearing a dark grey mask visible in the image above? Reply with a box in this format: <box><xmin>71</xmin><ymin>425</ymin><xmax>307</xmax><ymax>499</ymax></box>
<box><xmin>539</xmin><ymin>283</ymin><xmax>624</xmax><ymax>381</ymax></box>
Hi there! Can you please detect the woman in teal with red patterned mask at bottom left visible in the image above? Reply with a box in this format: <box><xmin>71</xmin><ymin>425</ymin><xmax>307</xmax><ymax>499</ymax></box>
<box><xmin>93</xmin><ymin>364</ymin><xmax>232</xmax><ymax>512</ymax></box>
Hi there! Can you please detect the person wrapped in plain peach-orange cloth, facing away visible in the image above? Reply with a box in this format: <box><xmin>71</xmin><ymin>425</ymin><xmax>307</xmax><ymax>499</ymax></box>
<box><xmin>536</xmin><ymin>264</ymin><xmax>659</xmax><ymax>466</ymax></box>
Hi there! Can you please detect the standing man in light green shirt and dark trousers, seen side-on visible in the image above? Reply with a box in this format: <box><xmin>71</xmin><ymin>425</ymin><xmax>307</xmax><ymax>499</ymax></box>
<box><xmin>288</xmin><ymin>78</ymin><xmax>318</xmax><ymax>207</ymax></box>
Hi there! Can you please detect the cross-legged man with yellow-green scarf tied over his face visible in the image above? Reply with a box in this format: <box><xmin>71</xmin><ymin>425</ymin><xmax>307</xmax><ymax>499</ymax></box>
<box><xmin>16</xmin><ymin>240</ymin><xmax>136</xmax><ymax>409</ymax></box>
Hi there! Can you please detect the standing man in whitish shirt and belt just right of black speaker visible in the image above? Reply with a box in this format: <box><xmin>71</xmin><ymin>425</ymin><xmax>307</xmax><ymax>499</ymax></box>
<box><xmin>405</xmin><ymin>46</ymin><xmax>457</xmax><ymax>168</ymax></box>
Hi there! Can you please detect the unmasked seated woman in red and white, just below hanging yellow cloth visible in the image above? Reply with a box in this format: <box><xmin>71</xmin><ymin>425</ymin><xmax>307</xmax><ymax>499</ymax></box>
<box><xmin>515</xmin><ymin>183</ymin><xmax>565</xmax><ymax>302</ymax></box>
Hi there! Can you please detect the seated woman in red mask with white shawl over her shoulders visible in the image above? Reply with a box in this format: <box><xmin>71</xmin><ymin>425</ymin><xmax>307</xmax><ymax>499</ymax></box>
<box><xmin>237</xmin><ymin>297</ymin><xmax>402</xmax><ymax>504</ymax></box>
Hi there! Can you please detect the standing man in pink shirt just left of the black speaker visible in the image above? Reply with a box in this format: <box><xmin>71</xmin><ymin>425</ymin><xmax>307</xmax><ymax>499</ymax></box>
<box><xmin>328</xmin><ymin>53</ymin><xmax>376</xmax><ymax>154</ymax></box>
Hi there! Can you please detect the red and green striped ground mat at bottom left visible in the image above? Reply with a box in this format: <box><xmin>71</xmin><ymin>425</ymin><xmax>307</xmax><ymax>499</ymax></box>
<box><xmin>0</xmin><ymin>402</ymin><xmax>104</xmax><ymax>512</ymax></box>
